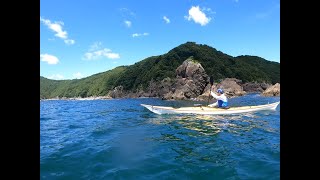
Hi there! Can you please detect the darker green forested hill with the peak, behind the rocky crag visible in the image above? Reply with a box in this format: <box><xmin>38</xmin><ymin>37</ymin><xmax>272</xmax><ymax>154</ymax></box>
<box><xmin>116</xmin><ymin>42</ymin><xmax>280</xmax><ymax>90</ymax></box>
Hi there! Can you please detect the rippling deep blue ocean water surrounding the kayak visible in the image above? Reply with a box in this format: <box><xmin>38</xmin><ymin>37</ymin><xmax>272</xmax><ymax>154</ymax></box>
<box><xmin>40</xmin><ymin>94</ymin><xmax>280</xmax><ymax>180</ymax></box>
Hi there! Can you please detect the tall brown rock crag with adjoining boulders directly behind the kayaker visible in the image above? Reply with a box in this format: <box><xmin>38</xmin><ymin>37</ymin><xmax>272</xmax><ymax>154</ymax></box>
<box><xmin>147</xmin><ymin>57</ymin><xmax>246</xmax><ymax>101</ymax></box>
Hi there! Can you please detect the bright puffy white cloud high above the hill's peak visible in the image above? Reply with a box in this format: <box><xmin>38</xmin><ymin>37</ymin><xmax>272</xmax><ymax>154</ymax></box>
<box><xmin>184</xmin><ymin>6</ymin><xmax>211</xmax><ymax>26</ymax></box>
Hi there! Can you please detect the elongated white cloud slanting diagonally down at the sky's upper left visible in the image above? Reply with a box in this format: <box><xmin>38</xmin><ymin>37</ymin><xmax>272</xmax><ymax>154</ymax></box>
<box><xmin>40</xmin><ymin>17</ymin><xmax>75</xmax><ymax>45</ymax></box>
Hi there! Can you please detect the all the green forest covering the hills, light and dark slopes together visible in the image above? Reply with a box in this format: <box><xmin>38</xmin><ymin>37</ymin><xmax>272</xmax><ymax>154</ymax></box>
<box><xmin>40</xmin><ymin>42</ymin><xmax>280</xmax><ymax>98</ymax></box>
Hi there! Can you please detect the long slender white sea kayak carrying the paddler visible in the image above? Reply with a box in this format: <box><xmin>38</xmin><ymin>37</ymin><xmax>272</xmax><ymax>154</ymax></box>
<box><xmin>141</xmin><ymin>101</ymin><xmax>280</xmax><ymax>115</ymax></box>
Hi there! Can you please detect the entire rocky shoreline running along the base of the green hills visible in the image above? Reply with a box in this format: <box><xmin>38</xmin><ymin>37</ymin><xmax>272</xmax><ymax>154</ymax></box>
<box><xmin>40</xmin><ymin>57</ymin><xmax>280</xmax><ymax>101</ymax></box>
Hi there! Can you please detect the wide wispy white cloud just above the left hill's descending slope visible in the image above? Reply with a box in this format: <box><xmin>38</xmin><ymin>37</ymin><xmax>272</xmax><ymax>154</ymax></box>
<box><xmin>84</xmin><ymin>42</ymin><xmax>120</xmax><ymax>60</ymax></box>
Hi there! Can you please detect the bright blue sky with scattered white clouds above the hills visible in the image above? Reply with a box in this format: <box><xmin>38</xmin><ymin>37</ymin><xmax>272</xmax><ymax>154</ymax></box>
<box><xmin>40</xmin><ymin>0</ymin><xmax>280</xmax><ymax>79</ymax></box>
